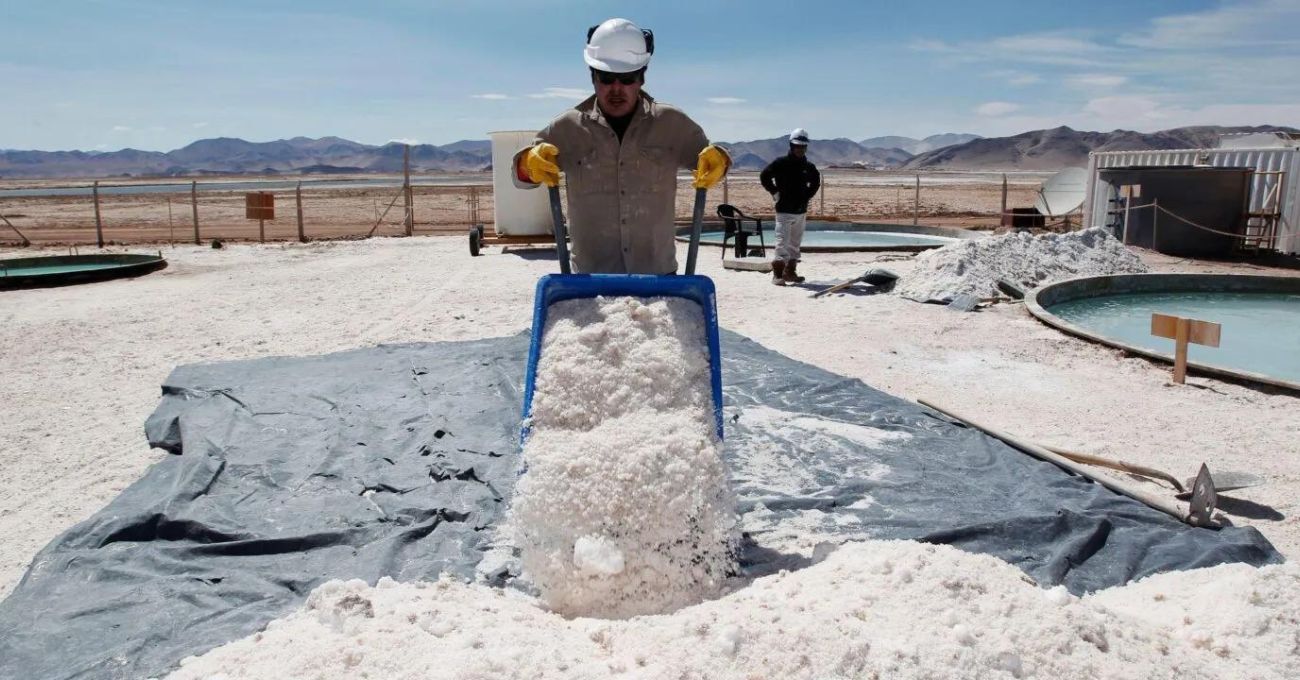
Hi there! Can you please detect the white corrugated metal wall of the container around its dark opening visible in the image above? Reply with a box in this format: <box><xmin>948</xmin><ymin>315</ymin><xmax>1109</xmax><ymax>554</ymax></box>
<box><xmin>1083</xmin><ymin>148</ymin><xmax>1300</xmax><ymax>254</ymax></box>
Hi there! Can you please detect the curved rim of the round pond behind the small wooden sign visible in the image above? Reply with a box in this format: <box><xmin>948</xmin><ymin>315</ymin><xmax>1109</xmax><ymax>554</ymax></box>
<box><xmin>1024</xmin><ymin>274</ymin><xmax>1300</xmax><ymax>393</ymax></box>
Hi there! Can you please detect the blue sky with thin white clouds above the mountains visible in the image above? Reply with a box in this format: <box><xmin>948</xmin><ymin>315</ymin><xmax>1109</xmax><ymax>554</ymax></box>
<box><xmin>0</xmin><ymin>0</ymin><xmax>1300</xmax><ymax>151</ymax></box>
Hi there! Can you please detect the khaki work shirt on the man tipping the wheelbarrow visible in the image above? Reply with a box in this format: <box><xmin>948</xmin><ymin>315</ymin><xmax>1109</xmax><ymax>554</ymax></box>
<box><xmin>511</xmin><ymin>92</ymin><xmax>709</xmax><ymax>274</ymax></box>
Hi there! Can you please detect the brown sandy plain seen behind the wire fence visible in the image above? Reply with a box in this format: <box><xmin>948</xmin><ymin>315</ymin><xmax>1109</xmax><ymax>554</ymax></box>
<box><xmin>0</xmin><ymin>170</ymin><xmax>1041</xmax><ymax>244</ymax></box>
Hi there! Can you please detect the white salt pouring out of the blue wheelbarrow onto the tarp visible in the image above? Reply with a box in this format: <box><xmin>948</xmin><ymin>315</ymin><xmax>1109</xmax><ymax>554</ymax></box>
<box><xmin>503</xmin><ymin>298</ymin><xmax>738</xmax><ymax>618</ymax></box>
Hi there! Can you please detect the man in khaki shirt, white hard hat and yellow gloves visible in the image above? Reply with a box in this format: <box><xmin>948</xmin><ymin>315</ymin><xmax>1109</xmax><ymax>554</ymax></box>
<box><xmin>515</xmin><ymin>18</ymin><xmax>731</xmax><ymax>274</ymax></box>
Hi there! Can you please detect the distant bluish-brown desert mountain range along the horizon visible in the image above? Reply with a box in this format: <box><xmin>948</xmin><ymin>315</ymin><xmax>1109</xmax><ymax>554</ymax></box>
<box><xmin>0</xmin><ymin>126</ymin><xmax>1296</xmax><ymax>178</ymax></box>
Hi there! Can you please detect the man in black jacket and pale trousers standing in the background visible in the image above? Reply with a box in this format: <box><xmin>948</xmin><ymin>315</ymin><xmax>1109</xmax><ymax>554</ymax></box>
<box><xmin>758</xmin><ymin>127</ymin><xmax>822</xmax><ymax>286</ymax></box>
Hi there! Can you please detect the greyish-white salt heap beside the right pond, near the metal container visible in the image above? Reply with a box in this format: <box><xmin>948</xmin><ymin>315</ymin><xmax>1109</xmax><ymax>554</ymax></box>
<box><xmin>896</xmin><ymin>228</ymin><xmax>1147</xmax><ymax>302</ymax></box>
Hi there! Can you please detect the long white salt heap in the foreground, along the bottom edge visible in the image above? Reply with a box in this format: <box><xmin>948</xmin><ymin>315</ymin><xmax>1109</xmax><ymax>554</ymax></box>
<box><xmin>172</xmin><ymin>541</ymin><xmax>1300</xmax><ymax>680</ymax></box>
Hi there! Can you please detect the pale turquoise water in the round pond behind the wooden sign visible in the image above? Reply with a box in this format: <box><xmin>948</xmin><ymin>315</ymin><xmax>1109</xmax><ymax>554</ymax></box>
<box><xmin>1048</xmin><ymin>291</ymin><xmax>1300</xmax><ymax>382</ymax></box>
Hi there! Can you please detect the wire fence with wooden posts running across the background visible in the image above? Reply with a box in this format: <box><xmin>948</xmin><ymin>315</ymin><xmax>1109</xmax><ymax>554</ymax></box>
<box><xmin>0</xmin><ymin>170</ymin><xmax>1036</xmax><ymax>244</ymax></box>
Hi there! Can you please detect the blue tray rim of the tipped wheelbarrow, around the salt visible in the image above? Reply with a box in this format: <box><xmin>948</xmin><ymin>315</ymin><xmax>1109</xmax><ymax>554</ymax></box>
<box><xmin>520</xmin><ymin>274</ymin><xmax>723</xmax><ymax>442</ymax></box>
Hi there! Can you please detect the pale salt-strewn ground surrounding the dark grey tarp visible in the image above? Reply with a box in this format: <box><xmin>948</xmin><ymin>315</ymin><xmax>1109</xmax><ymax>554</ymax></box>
<box><xmin>0</xmin><ymin>237</ymin><xmax>1300</xmax><ymax>595</ymax></box>
